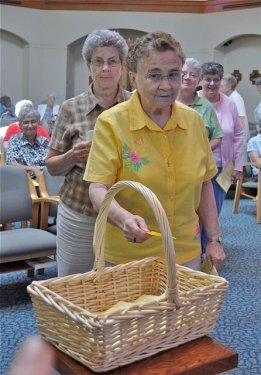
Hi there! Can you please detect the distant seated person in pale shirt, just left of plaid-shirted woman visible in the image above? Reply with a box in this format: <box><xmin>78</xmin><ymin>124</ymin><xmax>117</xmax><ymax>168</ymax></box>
<box><xmin>37</xmin><ymin>94</ymin><xmax>59</xmax><ymax>135</ymax></box>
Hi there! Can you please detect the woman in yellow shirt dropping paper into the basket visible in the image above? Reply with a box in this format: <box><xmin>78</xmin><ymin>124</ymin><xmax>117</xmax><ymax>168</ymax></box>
<box><xmin>84</xmin><ymin>32</ymin><xmax>225</xmax><ymax>269</ymax></box>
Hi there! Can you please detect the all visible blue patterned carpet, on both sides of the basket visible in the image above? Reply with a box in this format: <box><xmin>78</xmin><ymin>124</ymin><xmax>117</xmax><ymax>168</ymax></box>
<box><xmin>0</xmin><ymin>199</ymin><xmax>261</xmax><ymax>375</ymax></box>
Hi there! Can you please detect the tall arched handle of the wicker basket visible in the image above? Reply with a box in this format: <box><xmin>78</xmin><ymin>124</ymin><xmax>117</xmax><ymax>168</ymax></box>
<box><xmin>94</xmin><ymin>181</ymin><xmax>181</xmax><ymax>307</ymax></box>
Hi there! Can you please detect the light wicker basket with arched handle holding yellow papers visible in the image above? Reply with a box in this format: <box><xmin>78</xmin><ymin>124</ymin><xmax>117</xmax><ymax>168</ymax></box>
<box><xmin>28</xmin><ymin>181</ymin><xmax>228</xmax><ymax>372</ymax></box>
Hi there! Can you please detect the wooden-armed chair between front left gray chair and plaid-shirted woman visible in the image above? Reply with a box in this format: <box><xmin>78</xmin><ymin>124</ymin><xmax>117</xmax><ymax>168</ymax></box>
<box><xmin>37</xmin><ymin>167</ymin><xmax>64</xmax><ymax>234</ymax></box>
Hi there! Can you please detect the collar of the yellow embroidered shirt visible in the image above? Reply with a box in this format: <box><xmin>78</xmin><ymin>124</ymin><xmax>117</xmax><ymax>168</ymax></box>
<box><xmin>129</xmin><ymin>91</ymin><xmax>187</xmax><ymax>132</ymax></box>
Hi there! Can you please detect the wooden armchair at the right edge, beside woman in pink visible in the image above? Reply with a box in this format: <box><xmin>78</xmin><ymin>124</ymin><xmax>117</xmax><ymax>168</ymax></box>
<box><xmin>232</xmin><ymin>162</ymin><xmax>261</xmax><ymax>224</ymax></box>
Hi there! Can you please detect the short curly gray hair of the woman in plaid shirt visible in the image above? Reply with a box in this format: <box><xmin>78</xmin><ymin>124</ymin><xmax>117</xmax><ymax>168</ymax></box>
<box><xmin>82</xmin><ymin>29</ymin><xmax>128</xmax><ymax>64</ymax></box>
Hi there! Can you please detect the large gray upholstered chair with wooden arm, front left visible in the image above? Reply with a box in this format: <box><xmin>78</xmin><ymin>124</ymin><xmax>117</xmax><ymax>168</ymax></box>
<box><xmin>0</xmin><ymin>165</ymin><xmax>56</xmax><ymax>274</ymax></box>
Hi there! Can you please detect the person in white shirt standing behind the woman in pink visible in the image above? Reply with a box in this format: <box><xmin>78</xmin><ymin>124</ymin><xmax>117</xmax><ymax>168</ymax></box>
<box><xmin>220</xmin><ymin>74</ymin><xmax>250</xmax><ymax>142</ymax></box>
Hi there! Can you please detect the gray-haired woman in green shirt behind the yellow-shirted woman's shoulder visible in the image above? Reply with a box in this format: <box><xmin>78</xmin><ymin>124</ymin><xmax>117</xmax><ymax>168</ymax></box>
<box><xmin>177</xmin><ymin>57</ymin><xmax>223</xmax><ymax>150</ymax></box>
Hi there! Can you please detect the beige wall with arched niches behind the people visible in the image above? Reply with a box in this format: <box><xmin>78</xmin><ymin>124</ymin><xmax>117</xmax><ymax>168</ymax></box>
<box><xmin>1</xmin><ymin>5</ymin><xmax>261</xmax><ymax>121</ymax></box>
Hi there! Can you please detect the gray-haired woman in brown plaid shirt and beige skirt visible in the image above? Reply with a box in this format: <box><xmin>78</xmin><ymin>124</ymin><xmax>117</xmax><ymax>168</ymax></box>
<box><xmin>46</xmin><ymin>30</ymin><xmax>131</xmax><ymax>276</ymax></box>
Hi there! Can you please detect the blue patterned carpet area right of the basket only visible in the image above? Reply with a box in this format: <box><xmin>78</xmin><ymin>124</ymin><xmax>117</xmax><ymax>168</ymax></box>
<box><xmin>207</xmin><ymin>199</ymin><xmax>261</xmax><ymax>375</ymax></box>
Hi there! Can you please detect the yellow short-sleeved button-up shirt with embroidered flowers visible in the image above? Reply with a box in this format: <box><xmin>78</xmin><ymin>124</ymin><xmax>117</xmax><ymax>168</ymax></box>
<box><xmin>84</xmin><ymin>92</ymin><xmax>216</xmax><ymax>264</ymax></box>
